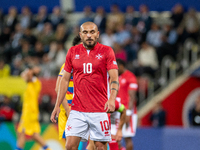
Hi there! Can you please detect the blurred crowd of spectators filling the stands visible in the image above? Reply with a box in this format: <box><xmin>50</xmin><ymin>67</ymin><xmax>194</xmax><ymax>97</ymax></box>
<box><xmin>0</xmin><ymin>4</ymin><xmax>200</xmax><ymax>126</ymax></box>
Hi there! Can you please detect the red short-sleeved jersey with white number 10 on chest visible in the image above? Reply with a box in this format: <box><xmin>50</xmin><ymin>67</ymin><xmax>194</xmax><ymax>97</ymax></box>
<box><xmin>64</xmin><ymin>43</ymin><xmax>118</xmax><ymax>112</ymax></box>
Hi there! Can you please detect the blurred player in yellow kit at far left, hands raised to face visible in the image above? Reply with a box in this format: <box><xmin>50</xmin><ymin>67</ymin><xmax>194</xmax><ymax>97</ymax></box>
<box><xmin>16</xmin><ymin>67</ymin><xmax>50</xmax><ymax>150</ymax></box>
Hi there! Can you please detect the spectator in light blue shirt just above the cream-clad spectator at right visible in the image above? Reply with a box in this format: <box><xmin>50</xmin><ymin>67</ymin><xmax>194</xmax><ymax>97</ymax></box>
<box><xmin>146</xmin><ymin>23</ymin><xmax>162</xmax><ymax>48</ymax></box>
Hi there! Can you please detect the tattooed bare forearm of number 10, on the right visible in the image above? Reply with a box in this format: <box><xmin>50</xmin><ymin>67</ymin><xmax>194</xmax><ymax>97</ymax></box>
<box><xmin>105</xmin><ymin>69</ymin><xmax>119</xmax><ymax>113</ymax></box>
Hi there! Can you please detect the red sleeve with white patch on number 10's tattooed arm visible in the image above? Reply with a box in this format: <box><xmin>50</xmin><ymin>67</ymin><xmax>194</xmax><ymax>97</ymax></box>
<box><xmin>106</xmin><ymin>48</ymin><xmax>118</xmax><ymax>70</ymax></box>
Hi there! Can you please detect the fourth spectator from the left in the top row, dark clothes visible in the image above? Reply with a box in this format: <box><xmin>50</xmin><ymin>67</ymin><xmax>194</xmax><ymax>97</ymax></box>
<box><xmin>50</xmin><ymin>6</ymin><xmax>65</xmax><ymax>31</ymax></box>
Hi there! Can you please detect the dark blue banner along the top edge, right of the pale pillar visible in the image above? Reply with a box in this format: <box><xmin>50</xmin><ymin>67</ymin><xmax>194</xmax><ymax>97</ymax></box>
<box><xmin>75</xmin><ymin>0</ymin><xmax>200</xmax><ymax>12</ymax></box>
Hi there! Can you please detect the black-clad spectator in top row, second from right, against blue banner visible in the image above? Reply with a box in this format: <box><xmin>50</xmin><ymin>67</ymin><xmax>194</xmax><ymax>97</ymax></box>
<box><xmin>171</xmin><ymin>3</ymin><xmax>184</xmax><ymax>29</ymax></box>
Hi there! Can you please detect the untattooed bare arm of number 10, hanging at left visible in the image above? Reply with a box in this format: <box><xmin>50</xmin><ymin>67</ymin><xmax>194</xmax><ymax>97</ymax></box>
<box><xmin>51</xmin><ymin>71</ymin><xmax>71</xmax><ymax>123</ymax></box>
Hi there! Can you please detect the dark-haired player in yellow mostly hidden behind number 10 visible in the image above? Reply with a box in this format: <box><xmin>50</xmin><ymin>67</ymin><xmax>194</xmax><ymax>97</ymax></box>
<box><xmin>55</xmin><ymin>36</ymin><xmax>81</xmax><ymax>139</ymax></box>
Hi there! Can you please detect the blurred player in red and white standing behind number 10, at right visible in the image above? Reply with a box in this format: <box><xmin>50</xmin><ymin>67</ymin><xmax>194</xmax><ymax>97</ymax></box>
<box><xmin>117</xmin><ymin>59</ymin><xmax>138</xmax><ymax>150</ymax></box>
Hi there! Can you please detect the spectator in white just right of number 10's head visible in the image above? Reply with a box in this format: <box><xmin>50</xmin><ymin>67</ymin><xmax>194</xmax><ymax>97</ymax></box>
<box><xmin>100</xmin><ymin>28</ymin><xmax>115</xmax><ymax>47</ymax></box>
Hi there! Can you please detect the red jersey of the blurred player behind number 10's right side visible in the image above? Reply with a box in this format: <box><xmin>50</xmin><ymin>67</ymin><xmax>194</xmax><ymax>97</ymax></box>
<box><xmin>117</xmin><ymin>70</ymin><xmax>138</xmax><ymax>108</ymax></box>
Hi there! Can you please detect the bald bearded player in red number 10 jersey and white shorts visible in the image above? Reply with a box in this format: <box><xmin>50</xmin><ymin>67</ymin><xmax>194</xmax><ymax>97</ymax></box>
<box><xmin>51</xmin><ymin>22</ymin><xmax>119</xmax><ymax>150</ymax></box>
